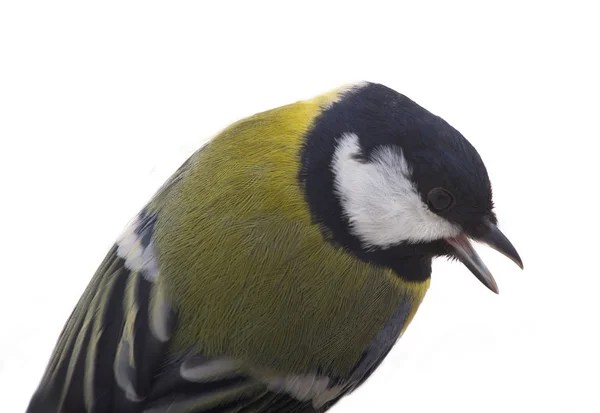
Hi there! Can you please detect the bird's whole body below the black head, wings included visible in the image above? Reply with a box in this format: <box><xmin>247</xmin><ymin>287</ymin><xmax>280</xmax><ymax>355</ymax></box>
<box><xmin>28</xmin><ymin>82</ymin><xmax>429</xmax><ymax>413</ymax></box>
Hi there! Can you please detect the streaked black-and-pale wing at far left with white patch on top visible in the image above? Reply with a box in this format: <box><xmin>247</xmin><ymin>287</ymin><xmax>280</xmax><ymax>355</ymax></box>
<box><xmin>28</xmin><ymin>209</ymin><xmax>175</xmax><ymax>413</ymax></box>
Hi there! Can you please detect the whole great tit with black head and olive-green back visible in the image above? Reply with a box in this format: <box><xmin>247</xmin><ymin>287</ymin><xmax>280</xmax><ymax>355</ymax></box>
<box><xmin>27</xmin><ymin>81</ymin><xmax>523</xmax><ymax>413</ymax></box>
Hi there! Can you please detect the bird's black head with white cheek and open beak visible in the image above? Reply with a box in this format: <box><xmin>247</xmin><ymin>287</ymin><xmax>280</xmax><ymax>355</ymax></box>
<box><xmin>300</xmin><ymin>83</ymin><xmax>522</xmax><ymax>292</ymax></box>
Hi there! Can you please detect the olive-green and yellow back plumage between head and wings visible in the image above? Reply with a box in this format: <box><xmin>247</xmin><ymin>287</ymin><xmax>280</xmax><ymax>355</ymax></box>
<box><xmin>153</xmin><ymin>93</ymin><xmax>428</xmax><ymax>377</ymax></box>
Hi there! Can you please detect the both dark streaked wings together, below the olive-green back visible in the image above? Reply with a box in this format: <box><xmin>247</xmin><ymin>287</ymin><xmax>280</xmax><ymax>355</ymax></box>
<box><xmin>27</xmin><ymin>204</ymin><xmax>412</xmax><ymax>413</ymax></box>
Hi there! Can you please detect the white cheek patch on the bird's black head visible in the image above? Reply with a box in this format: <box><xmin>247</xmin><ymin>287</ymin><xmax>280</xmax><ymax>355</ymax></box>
<box><xmin>332</xmin><ymin>133</ymin><xmax>460</xmax><ymax>248</ymax></box>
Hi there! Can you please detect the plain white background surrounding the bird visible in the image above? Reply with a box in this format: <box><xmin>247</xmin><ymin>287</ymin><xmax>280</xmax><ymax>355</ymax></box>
<box><xmin>0</xmin><ymin>0</ymin><xmax>600</xmax><ymax>413</ymax></box>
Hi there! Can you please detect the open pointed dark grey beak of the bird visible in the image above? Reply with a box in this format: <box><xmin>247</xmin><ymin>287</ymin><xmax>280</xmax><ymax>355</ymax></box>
<box><xmin>446</xmin><ymin>224</ymin><xmax>523</xmax><ymax>294</ymax></box>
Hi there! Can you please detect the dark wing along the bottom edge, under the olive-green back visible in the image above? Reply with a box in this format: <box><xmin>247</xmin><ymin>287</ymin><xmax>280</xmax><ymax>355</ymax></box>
<box><xmin>137</xmin><ymin>294</ymin><xmax>414</xmax><ymax>413</ymax></box>
